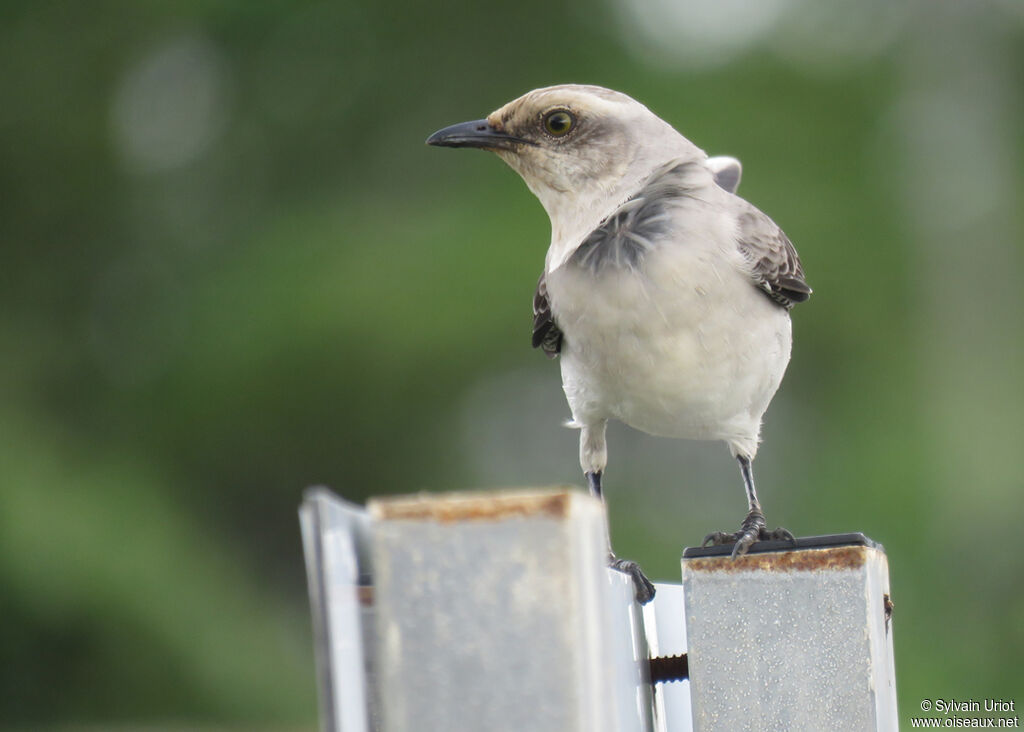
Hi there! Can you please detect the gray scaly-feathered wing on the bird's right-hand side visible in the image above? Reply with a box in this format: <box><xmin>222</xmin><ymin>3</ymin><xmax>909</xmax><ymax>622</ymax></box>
<box><xmin>737</xmin><ymin>201</ymin><xmax>811</xmax><ymax>310</ymax></box>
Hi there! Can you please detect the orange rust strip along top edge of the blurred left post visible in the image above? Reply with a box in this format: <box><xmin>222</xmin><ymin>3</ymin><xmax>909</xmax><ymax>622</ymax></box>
<box><xmin>367</xmin><ymin>489</ymin><xmax>583</xmax><ymax>523</ymax></box>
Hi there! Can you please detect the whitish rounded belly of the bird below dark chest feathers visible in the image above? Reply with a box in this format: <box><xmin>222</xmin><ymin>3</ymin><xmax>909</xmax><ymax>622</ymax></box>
<box><xmin>547</xmin><ymin>248</ymin><xmax>792</xmax><ymax>457</ymax></box>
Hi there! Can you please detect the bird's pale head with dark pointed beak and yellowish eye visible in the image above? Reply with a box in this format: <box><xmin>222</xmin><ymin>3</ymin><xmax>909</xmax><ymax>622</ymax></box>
<box><xmin>427</xmin><ymin>84</ymin><xmax>707</xmax><ymax>234</ymax></box>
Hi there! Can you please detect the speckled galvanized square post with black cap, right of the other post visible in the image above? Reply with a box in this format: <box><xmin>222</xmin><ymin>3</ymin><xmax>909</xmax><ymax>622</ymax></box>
<box><xmin>683</xmin><ymin>534</ymin><xmax>898</xmax><ymax>731</ymax></box>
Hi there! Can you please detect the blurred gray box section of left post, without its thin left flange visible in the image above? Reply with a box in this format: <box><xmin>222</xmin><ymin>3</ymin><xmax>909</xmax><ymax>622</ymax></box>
<box><xmin>368</xmin><ymin>490</ymin><xmax>649</xmax><ymax>732</ymax></box>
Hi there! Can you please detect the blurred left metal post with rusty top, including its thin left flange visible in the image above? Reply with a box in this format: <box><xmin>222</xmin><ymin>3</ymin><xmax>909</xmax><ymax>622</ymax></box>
<box><xmin>300</xmin><ymin>490</ymin><xmax>659</xmax><ymax>732</ymax></box>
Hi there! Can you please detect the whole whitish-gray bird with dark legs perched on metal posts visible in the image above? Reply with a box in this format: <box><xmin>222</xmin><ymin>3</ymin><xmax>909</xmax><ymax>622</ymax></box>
<box><xmin>427</xmin><ymin>84</ymin><xmax>811</xmax><ymax>603</ymax></box>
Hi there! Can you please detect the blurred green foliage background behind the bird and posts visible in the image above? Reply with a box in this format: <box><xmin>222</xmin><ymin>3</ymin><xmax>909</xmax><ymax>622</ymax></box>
<box><xmin>0</xmin><ymin>0</ymin><xmax>1024</xmax><ymax>730</ymax></box>
